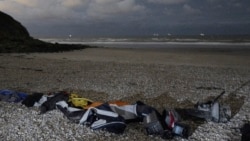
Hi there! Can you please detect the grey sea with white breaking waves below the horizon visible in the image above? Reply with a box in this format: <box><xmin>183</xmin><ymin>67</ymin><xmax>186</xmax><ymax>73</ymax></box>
<box><xmin>39</xmin><ymin>37</ymin><xmax>250</xmax><ymax>49</ymax></box>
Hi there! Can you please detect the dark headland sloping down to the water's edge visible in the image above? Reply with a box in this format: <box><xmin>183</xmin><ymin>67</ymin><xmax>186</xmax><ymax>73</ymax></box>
<box><xmin>0</xmin><ymin>11</ymin><xmax>89</xmax><ymax>53</ymax></box>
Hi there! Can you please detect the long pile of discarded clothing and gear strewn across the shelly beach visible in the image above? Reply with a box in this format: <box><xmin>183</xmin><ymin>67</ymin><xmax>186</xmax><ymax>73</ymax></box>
<box><xmin>0</xmin><ymin>90</ymin><xmax>236</xmax><ymax>139</ymax></box>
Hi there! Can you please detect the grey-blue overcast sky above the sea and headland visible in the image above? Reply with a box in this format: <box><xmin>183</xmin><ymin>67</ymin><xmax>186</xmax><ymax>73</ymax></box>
<box><xmin>0</xmin><ymin>0</ymin><xmax>250</xmax><ymax>37</ymax></box>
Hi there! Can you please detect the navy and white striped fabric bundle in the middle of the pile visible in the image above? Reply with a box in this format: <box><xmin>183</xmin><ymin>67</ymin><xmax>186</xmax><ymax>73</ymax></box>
<box><xmin>56</xmin><ymin>101</ymin><xmax>126</xmax><ymax>134</ymax></box>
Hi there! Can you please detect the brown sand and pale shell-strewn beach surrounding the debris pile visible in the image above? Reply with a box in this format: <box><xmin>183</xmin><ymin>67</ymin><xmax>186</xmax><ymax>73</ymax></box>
<box><xmin>0</xmin><ymin>48</ymin><xmax>250</xmax><ymax>141</ymax></box>
